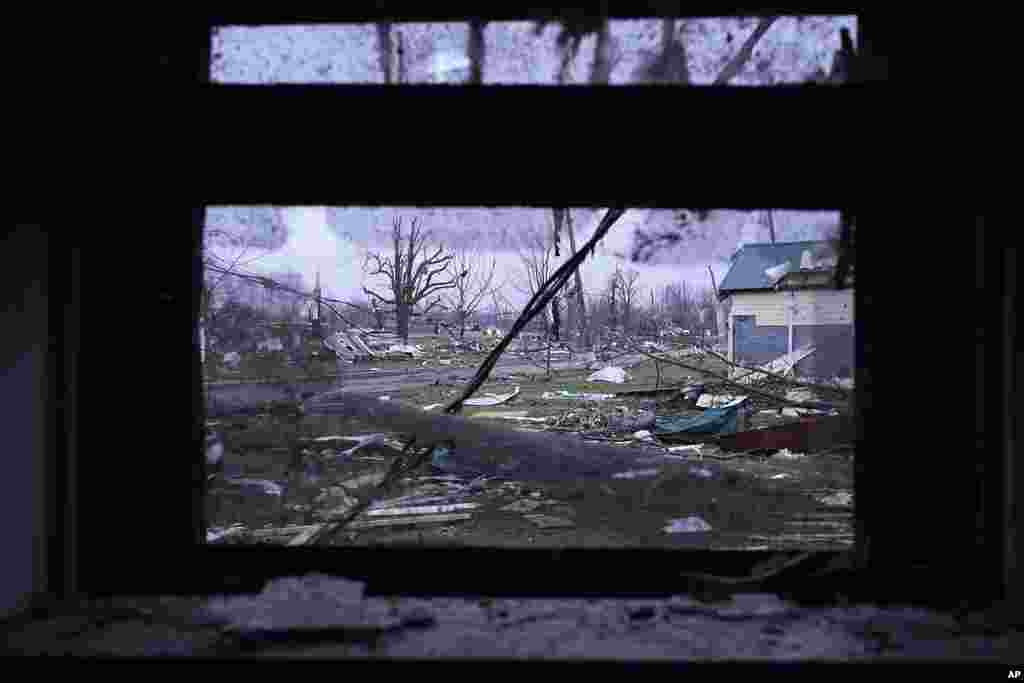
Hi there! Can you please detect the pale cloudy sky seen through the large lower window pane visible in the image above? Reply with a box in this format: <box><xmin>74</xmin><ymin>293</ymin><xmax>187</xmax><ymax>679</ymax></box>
<box><xmin>205</xmin><ymin>207</ymin><xmax>839</xmax><ymax>304</ymax></box>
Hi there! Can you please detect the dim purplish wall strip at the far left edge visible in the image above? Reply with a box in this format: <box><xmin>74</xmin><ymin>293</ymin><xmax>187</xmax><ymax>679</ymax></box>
<box><xmin>0</xmin><ymin>225</ymin><xmax>51</xmax><ymax>615</ymax></box>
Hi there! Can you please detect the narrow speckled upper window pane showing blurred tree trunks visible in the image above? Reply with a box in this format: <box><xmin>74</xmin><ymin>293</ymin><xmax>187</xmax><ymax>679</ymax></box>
<box><xmin>211</xmin><ymin>16</ymin><xmax>857</xmax><ymax>86</ymax></box>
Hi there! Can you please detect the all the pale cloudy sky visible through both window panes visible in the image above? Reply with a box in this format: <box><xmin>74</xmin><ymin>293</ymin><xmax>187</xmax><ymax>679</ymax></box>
<box><xmin>208</xmin><ymin>16</ymin><xmax>856</xmax><ymax>304</ymax></box>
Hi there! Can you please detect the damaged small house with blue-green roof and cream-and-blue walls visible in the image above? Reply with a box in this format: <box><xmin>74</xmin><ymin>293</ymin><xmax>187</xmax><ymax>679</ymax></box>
<box><xmin>719</xmin><ymin>241</ymin><xmax>855</xmax><ymax>378</ymax></box>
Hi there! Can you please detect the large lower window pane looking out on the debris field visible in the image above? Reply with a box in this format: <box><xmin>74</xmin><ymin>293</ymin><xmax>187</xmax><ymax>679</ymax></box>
<box><xmin>200</xmin><ymin>206</ymin><xmax>854</xmax><ymax>549</ymax></box>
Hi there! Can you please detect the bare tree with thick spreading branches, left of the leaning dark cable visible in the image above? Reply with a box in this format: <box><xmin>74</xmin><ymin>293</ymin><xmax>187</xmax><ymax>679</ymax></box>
<box><xmin>362</xmin><ymin>218</ymin><xmax>456</xmax><ymax>344</ymax></box>
